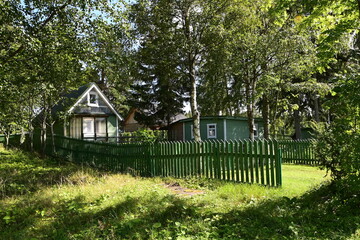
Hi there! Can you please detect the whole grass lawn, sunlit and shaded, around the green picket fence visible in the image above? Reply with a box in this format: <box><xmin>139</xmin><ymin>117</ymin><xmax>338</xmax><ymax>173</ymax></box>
<box><xmin>0</xmin><ymin>150</ymin><xmax>360</xmax><ymax>239</ymax></box>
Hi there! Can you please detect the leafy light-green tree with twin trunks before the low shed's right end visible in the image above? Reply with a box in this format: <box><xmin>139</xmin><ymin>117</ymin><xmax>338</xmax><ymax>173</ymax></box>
<box><xmin>200</xmin><ymin>0</ymin><xmax>314</xmax><ymax>139</ymax></box>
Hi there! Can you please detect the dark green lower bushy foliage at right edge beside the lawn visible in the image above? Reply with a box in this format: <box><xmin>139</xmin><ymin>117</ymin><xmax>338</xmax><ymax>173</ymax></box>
<box><xmin>317</xmin><ymin>52</ymin><xmax>360</xmax><ymax>178</ymax></box>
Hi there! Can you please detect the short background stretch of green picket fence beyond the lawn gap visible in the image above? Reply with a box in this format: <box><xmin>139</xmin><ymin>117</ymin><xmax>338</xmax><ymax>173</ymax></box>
<box><xmin>278</xmin><ymin>140</ymin><xmax>319</xmax><ymax>165</ymax></box>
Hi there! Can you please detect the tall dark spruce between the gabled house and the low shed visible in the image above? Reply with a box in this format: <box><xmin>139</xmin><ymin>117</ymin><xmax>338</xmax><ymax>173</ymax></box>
<box><xmin>129</xmin><ymin>1</ymin><xmax>186</xmax><ymax>126</ymax></box>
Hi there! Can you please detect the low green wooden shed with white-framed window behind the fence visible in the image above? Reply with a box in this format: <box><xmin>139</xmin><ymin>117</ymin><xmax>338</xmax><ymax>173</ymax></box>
<box><xmin>168</xmin><ymin>116</ymin><xmax>264</xmax><ymax>141</ymax></box>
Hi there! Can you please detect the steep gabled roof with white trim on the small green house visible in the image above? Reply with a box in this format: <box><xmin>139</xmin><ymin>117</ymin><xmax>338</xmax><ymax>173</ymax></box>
<box><xmin>52</xmin><ymin>83</ymin><xmax>123</xmax><ymax>120</ymax></box>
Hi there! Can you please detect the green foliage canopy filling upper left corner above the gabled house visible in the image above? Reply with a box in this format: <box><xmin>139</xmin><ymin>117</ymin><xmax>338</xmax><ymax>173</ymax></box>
<box><xmin>0</xmin><ymin>0</ymin><xmax>132</xmax><ymax>146</ymax></box>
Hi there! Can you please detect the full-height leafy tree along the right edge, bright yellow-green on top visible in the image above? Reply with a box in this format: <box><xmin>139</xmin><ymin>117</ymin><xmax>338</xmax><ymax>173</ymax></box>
<box><xmin>289</xmin><ymin>0</ymin><xmax>360</xmax><ymax>178</ymax></box>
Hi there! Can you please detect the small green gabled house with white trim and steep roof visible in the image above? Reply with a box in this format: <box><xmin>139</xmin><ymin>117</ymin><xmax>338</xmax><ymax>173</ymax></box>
<box><xmin>52</xmin><ymin>83</ymin><xmax>123</xmax><ymax>142</ymax></box>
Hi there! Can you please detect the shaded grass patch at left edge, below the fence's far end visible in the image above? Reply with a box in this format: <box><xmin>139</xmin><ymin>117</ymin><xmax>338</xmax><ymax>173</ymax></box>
<box><xmin>0</xmin><ymin>150</ymin><xmax>101</xmax><ymax>200</ymax></box>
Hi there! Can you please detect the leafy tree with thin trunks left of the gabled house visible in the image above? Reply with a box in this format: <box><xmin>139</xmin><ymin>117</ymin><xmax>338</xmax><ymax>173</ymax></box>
<box><xmin>0</xmin><ymin>0</ymin><xmax>129</xmax><ymax>150</ymax></box>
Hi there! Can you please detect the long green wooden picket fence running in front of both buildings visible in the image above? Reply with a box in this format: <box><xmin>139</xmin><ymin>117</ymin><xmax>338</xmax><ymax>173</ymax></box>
<box><xmin>26</xmin><ymin>136</ymin><xmax>282</xmax><ymax>186</ymax></box>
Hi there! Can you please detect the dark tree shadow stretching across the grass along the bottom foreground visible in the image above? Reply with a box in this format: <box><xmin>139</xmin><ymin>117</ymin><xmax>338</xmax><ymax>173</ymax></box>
<box><xmin>0</xmin><ymin>180</ymin><xmax>360</xmax><ymax>239</ymax></box>
